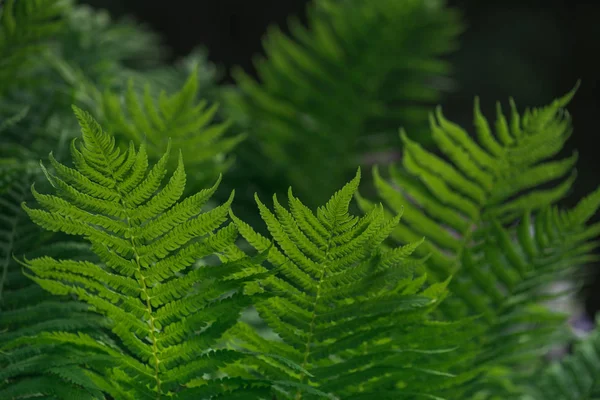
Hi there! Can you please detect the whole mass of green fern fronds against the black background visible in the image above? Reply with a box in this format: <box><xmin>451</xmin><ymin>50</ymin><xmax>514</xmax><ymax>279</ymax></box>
<box><xmin>0</xmin><ymin>0</ymin><xmax>600</xmax><ymax>400</ymax></box>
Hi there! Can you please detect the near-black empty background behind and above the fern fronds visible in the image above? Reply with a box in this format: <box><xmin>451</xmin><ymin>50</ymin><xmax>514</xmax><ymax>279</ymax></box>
<box><xmin>79</xmin><ymin>0</ymin><xmax>600</xmax><ymax>315</ymax></box>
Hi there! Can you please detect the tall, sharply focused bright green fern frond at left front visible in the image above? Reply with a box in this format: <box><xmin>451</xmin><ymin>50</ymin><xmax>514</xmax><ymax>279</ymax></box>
<box><xmin>23</xmin><ymin>108</ymin><xmax>269</xmax><ymax>399</ymax></box>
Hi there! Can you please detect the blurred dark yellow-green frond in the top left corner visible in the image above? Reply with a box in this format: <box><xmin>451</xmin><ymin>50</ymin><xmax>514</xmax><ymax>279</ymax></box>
<box><xmin>0</xmin><ymin>0</ymin><xmax>66</xmax><ymax>94</ymax></box>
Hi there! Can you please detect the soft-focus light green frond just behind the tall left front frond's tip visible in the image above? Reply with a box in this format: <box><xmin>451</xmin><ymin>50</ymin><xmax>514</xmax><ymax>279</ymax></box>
<box><xmin>86</xmin><ymin>69</ymin><xmax>244</xmax><ymax>188</ymax></box>
